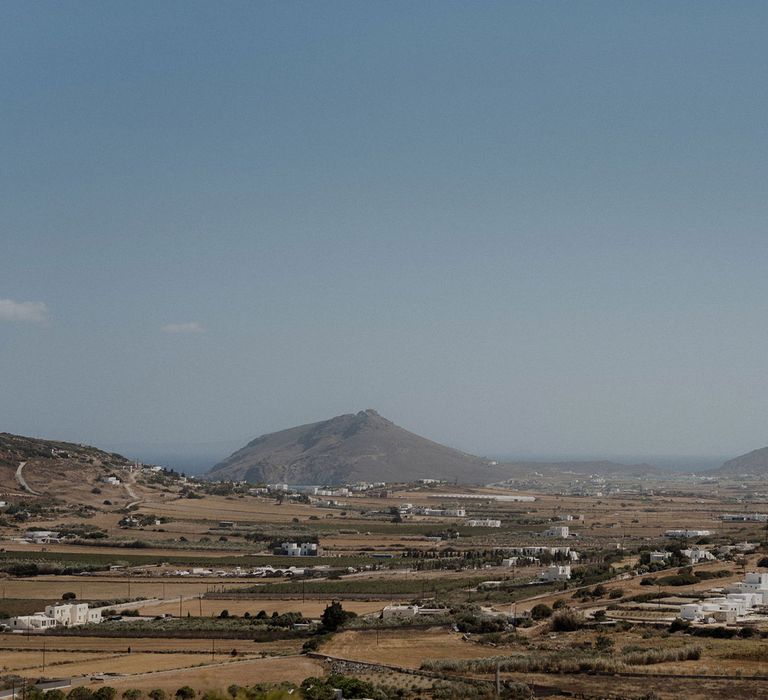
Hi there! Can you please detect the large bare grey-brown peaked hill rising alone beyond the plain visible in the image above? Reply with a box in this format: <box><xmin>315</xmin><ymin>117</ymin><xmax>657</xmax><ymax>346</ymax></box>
<box><xmin>206</xmin><ymin>410</ymin><xmax>492</xmax><ymax>485</ymax></box>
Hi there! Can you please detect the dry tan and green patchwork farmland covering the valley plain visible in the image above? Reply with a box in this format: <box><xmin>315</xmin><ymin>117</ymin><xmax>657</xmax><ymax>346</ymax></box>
<box><xmin>0</xmin><ymin>473</ymin><xmax>768</xmax><ymax>700</ymax></box>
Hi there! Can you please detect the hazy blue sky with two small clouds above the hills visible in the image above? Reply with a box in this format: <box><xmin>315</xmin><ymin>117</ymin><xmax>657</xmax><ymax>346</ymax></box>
<box><xmin>0</xmin><ymin>0</ymin><xmax>768</xmax><ymax>470</ymax></box>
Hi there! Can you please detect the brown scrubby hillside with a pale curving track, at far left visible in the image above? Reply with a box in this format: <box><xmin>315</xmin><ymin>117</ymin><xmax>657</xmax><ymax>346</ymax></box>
<box><xmin>0</xmin><ymin>433</ymin><xmax>134</xmax><ymax>503</ymax></box>
